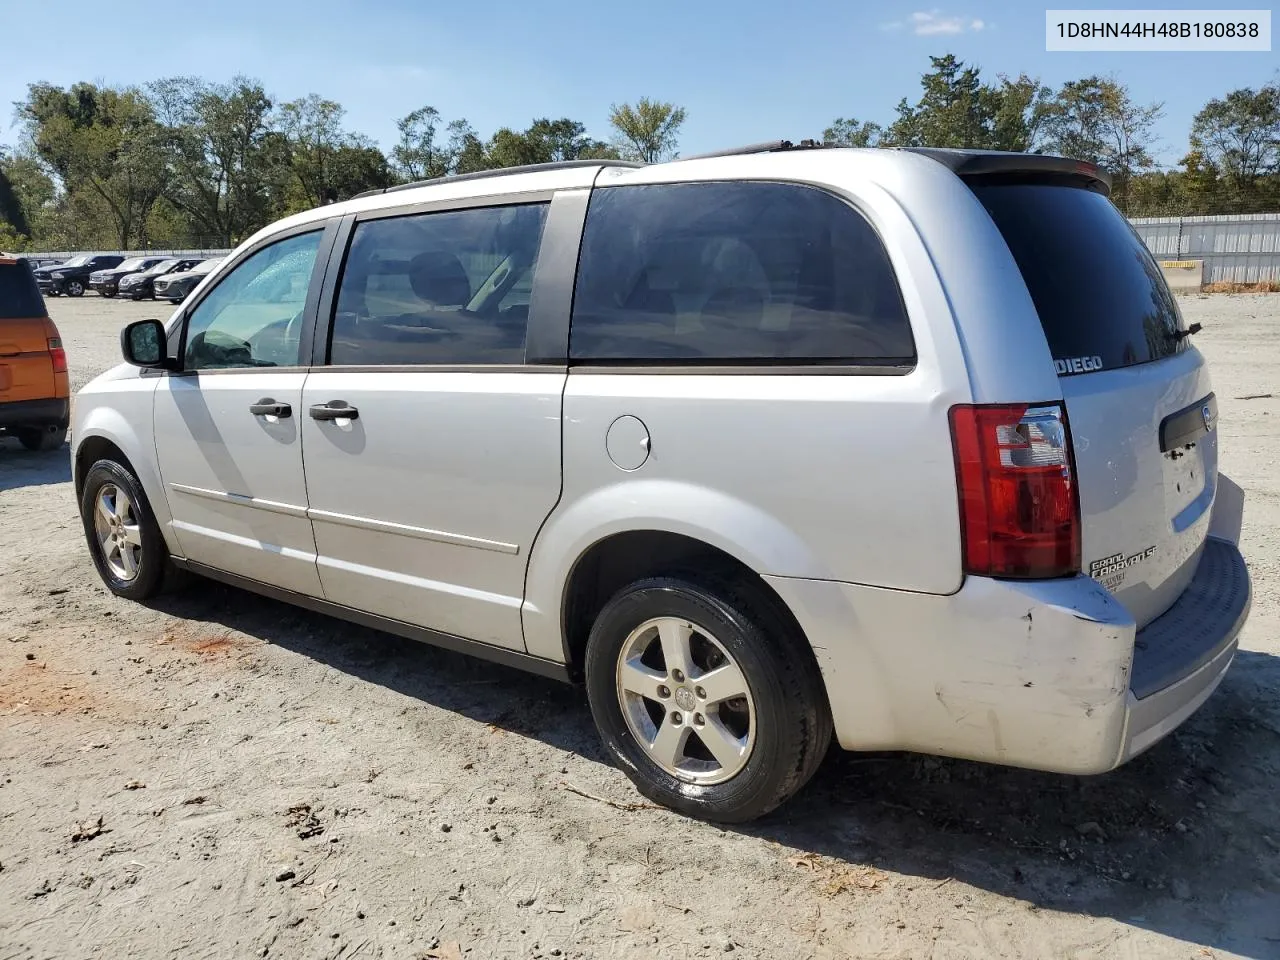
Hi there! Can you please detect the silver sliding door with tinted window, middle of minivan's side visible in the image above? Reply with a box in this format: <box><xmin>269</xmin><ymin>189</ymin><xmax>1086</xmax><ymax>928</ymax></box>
<box><xmin>298</xmin><ymin>204</ymin><xmax>564</xmax><ymax>649</ymax></box>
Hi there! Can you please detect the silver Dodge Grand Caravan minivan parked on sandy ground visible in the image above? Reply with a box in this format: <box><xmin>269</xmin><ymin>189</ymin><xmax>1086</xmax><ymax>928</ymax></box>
<box><xmin>73</xmin><ymin>142</ymin><xmax>1251</xmax><ymax>822</ymax></box>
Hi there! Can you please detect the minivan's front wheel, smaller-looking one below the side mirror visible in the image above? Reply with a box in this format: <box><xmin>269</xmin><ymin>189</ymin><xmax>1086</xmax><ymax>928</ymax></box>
<box><xmin>81</xmin><ymin>460</ymin><xmax>169</xmax><ymax>602</ymax></box>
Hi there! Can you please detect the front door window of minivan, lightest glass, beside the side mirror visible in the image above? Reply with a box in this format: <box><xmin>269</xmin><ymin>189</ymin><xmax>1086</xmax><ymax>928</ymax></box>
<box><xmin>184</xmin><ymin>232</ymin><xmax>320</xmax><ymax>370</ymax></box>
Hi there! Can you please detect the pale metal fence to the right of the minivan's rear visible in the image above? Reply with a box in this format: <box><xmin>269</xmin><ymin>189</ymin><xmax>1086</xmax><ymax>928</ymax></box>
<box><xmin>1132</xmin><ymin>214</ymin><xmax>1280</xmax><ymax>283</ymax></box>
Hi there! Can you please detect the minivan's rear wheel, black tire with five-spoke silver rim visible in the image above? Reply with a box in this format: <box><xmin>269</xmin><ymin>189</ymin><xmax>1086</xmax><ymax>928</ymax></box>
<box><xmin>585</xmin><ymin>577</ymin><xmax>832</xmax><ymax>823</ymax></box>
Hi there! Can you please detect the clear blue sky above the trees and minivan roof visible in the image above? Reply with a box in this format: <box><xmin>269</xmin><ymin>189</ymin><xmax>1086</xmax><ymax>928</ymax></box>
<box><xmin>0</xmin><ymin>0</ymin><xmax>1280</xmax><ymax>163</ymax></box>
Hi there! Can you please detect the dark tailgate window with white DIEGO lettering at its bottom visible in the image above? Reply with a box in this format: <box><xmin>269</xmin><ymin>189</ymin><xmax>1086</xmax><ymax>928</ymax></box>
<box><xmin>973</xmin><ymin>183</ymin><xmax>1183</xmax><ymax>375</ymax></box>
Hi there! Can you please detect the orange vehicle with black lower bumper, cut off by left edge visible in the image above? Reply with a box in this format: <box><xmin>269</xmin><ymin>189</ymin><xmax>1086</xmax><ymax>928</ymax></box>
<box><xmin>0</xmin><ymin>253</ymin><xmax>70</xmax><ymax>451</ymax></box>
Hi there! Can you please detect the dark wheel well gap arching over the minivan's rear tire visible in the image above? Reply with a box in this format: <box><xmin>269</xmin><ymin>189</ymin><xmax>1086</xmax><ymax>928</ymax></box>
<box><xmin>563</xmin><ymin>530</ymin><xmax>817</xmax><ymax>677</ymax></box>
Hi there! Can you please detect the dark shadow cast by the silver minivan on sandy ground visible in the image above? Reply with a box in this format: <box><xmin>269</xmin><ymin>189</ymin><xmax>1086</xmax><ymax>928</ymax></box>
<box><xmin>157</xmin><ymin>581</ymin><xmax>1280</xmax><ymax>960</ymax></box>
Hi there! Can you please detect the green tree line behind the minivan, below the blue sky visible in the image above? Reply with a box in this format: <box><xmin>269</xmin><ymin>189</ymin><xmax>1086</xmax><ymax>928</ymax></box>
<box><xmin>0</xmin><ymin>55</ymin><xmax>1280</xmax><ymax>250</ymax></box>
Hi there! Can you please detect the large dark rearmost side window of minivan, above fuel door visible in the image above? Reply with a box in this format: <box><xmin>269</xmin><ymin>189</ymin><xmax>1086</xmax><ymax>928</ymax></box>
<box><xmin>570</xmin><ymin>183</ymin><xmax>915</xmax><ymax>362</ymax></box>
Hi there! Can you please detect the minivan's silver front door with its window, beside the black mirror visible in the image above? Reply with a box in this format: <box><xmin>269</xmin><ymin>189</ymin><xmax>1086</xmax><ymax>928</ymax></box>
<box><xmin>155</xmin><ymin>227</ymin><xmax>323</xmax><ymax>596</ymax></box>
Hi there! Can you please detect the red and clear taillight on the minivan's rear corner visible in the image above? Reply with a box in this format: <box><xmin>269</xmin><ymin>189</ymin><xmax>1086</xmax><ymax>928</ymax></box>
<box><xmin>951</xmin><ymin>403</ymin><xmax>1080</xmax><ymax>580</ymax></box>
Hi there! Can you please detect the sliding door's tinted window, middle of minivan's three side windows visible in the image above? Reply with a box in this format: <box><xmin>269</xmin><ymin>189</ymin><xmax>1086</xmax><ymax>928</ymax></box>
<box><xmin>329</xmin><ymin>204</ymin><xmax>547</xmax><ymax>366</ymax></box>
